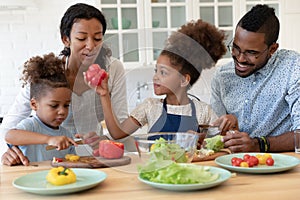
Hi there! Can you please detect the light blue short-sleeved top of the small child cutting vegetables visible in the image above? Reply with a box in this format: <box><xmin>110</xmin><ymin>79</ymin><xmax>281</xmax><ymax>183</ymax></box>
<box><xmin>16</xmin><ymin>115</ymin><xmax>76</xmax><ymax>162</ymax></box>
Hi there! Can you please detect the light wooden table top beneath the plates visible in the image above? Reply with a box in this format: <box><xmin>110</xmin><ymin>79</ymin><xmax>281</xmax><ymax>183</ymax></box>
<box><xmin>0</xmin><ymin>152</ymin><xmax>300</xmax><ymax>200</ymax></box>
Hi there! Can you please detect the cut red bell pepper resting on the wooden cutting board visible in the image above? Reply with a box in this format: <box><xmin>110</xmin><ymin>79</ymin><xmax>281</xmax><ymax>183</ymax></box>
<box><xmin>99</xmin><ymin>140</ymin><xmax>124</xmax><ymax>159</ymax></box>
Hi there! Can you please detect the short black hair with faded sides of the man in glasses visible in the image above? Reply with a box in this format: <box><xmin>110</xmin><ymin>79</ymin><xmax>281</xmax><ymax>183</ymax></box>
<box><xmin>238</xmin><ymin>4</ymin><xmax>280</xmax><ymax>46</ymax></box>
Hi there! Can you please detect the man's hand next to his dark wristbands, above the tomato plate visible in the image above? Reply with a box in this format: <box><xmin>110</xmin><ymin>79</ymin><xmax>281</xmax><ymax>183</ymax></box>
<box><xmin>223</xmin><ymin>131</ymin><xmax>259</xmax><ymax>153</ymax></box>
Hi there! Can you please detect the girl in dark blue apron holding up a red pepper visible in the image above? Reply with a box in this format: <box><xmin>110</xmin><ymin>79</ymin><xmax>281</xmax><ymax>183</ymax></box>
<box><xmin>89</xmin><ymin>20</ymin><xmax>237</xmax><ymax>139</ymax></box>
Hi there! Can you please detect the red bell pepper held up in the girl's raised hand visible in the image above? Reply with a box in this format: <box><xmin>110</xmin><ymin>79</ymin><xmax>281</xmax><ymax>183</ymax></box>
<box><xmin>85</xmin><ymin>64</ymin><xmax>107</xmax><ymax>87</ymax></box>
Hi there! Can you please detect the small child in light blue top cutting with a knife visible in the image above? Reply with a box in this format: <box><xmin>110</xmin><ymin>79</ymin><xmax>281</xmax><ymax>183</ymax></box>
<box><xmin>5</xmin><ymin>53</ymin><xmax>76</xmax><ymax>162</ymax></box>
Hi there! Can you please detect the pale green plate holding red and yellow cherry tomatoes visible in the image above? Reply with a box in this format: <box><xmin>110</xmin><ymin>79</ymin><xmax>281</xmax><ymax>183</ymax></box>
<box><xmin>215</xmin><ymin>153</ymin><xmax>300</xmax><ymax>174</ymax></box>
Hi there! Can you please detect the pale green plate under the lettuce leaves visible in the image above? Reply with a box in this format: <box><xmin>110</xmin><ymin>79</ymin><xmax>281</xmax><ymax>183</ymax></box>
<box><xmin>138</xmin><ymin>166</ymin><xmax>231</xmax><ymax>191</ymax></box>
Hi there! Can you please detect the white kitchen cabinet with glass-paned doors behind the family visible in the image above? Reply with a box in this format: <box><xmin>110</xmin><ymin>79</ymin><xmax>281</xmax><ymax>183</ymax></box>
<box><xmin>97</xmin><ymin>0</ymin><xmax>280</xmax><ymax>68</ymax></box>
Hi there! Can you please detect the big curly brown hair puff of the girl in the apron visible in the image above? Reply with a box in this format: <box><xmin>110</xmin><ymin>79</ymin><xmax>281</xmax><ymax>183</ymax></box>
<box><xmin>161</xmin><ymin>19</ymin><xmax>226</xmax><ymax>86</ymax></box>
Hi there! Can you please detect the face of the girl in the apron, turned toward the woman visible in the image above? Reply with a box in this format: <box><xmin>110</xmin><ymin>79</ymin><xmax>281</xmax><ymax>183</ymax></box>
<box><xmin>153</xmin><ymin>55</ymin><xmax>184</xmax><ymax>95</ymax></box>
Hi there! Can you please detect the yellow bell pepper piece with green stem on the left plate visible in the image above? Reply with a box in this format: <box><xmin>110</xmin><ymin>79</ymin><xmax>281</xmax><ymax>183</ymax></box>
<box><xmin>46</xmin><ymin>166</ymin><xmax>76</xmax><ymax>185</ymax></box>
